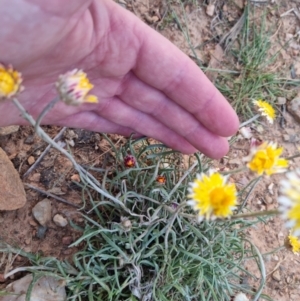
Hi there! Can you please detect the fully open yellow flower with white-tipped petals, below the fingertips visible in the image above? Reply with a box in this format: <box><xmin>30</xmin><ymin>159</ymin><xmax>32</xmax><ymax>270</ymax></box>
<box><xmin>187</xmin><ymin>171</ymin><xmax>237</xmax><ymax>221</ymax></box>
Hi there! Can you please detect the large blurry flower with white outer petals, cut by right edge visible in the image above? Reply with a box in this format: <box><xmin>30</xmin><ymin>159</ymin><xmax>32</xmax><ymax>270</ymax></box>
<box><xmin>278</xmin><ymin>170</ymin><xmax>300</xmax><ymax>236</ymax></box>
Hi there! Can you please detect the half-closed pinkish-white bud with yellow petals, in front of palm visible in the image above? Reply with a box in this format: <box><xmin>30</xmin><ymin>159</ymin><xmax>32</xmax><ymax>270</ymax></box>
<box><xmin>56</xmin><ymin>69</ymin><xmax>98</xmax><ymax>106</ymax></box>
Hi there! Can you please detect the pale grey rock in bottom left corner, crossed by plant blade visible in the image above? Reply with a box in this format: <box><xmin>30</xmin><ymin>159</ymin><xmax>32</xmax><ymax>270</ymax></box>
<box><xmin>0</xmin><ymin>274</ymin><xmax>67</xmax><ymax>301</ymax></box>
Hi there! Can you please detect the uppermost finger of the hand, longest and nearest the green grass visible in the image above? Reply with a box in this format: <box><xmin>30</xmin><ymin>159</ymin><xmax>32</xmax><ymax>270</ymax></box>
<box><xmin>111</xmin><ymin>0</ymin><xmax>239</xmax><ymax>136</ymax></box>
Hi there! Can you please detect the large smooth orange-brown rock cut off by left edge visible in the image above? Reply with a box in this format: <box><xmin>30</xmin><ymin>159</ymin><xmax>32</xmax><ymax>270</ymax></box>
<box><xmin>0</xmin><ymin>148</ymin><xmax>26</xmax><ymax>210</ymax></box>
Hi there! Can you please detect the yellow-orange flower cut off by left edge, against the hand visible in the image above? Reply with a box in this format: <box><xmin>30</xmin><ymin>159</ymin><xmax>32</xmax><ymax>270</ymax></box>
<box><xmin>0</xmin><ymin>64</ymin><xmax>23</xmax><ymax>100</ymax></box>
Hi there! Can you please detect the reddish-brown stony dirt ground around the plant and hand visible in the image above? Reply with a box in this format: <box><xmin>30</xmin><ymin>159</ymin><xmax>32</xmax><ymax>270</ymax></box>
<box><xmin>0</xmin><ymin>0</ymin><xmax>300</xmax><ymax>301</ymax></box>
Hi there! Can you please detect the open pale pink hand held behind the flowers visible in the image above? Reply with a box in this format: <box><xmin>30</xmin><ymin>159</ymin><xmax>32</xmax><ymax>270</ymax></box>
<box><xmin>0</xmin><ymin>0</ymin><xmax>239</xmax><ymax>158</ymax></box>
